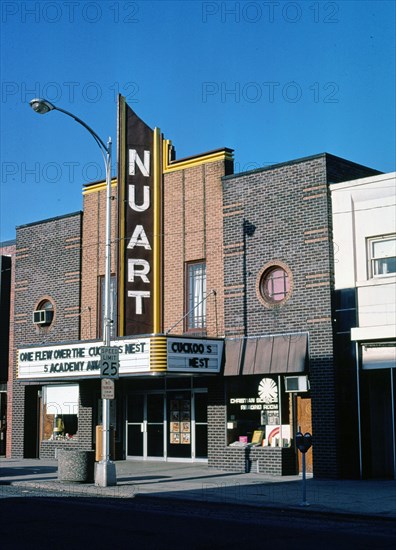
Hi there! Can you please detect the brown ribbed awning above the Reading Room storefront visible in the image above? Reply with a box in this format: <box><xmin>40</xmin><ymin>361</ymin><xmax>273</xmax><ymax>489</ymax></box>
<box><xmin>224</xmin><ymin>332</ymin><xmax>308</xmax><ymax>376</ymax></box>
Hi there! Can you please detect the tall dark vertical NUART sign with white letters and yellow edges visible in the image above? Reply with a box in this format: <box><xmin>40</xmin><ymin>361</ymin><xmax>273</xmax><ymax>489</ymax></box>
<box><xmin>118</xmin><ymin>96</ymin><xmax>162</xmax><ymax>336</ymax></box>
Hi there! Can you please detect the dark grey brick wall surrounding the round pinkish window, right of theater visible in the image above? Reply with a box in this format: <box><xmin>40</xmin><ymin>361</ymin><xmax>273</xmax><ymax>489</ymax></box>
<box><xmin>217</xmin><ymin>154</ymin><xmax>376</xmax><ymax>477</ymax></box>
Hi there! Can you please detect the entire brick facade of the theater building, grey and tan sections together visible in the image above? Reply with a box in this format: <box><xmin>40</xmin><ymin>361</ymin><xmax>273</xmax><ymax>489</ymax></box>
<box><xmin>9</xmin><ymin>140</ymin><xmax>382</xmax><ymax>477</ymax></box>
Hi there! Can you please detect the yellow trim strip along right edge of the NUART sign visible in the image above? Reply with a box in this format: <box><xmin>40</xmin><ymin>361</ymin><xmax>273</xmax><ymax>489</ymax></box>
<box><xmin>153</xmin><ymin>128</ymin><xmax>162</xmax><ymax>334</ymax></box>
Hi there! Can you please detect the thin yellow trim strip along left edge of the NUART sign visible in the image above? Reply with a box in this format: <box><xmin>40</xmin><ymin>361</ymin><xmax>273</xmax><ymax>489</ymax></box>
<box><xmin>118</xmin><ymin>96</ymin><xmax>126</xmax><ymax>336</ymax></box>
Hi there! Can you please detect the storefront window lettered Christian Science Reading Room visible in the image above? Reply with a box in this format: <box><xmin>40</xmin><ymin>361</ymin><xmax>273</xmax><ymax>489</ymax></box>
<box><xmin>227</xmin><ymin>376</ymin><xmax>291</xmax><ymax>447</ymax></box>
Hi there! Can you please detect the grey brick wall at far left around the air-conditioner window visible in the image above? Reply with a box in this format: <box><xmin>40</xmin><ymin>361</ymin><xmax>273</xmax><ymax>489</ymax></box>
<box><xmin>9</xmin><ymin>212</ymin><xmax>81</xmax><ymax>457</ymax></box>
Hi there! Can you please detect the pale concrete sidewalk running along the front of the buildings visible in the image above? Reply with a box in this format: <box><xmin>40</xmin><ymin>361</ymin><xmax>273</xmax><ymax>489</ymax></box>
<box><xmin>0</xmin><ymin>458</ymin><xmax>396</xmax><ymax>519</ymax></box>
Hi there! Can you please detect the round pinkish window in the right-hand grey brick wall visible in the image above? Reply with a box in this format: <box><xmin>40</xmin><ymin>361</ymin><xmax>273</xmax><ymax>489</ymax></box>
<box><xmin>257</xmin><ymin>263</ymin><xmax>292</xmax><ymax>306</ymax></box>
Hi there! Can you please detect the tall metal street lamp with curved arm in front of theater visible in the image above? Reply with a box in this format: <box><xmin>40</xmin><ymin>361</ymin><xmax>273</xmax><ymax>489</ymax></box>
<box><xmin>30</xmin><ymin>98</ymin><xmax>117</xmax><ymax>487</ymax></box>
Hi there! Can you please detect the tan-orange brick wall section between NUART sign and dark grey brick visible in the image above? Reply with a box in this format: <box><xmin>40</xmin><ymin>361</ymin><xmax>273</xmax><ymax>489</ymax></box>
<box><xmin>163</xmin><ymin>161</ymin><xmax>227</xmax><ymax>336</ymax></box>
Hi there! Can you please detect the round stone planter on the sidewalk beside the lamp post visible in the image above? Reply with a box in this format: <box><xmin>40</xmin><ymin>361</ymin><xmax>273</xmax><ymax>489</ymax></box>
<box><xmin>58</xmin><ymin>449</ymin><xmax>95</xmax><ymax>483</ymax></box>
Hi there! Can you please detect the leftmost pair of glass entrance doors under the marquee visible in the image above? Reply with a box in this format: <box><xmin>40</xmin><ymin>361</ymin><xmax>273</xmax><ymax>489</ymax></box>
<box><xmin>127</xmin><ymin>393</ymin><xmax>164</xmax><ymax>458</ymax></box>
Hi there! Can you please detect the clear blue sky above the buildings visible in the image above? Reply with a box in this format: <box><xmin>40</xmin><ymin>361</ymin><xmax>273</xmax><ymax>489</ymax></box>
<box><xmin>0</xmin><ymin>0</ymin><xmax>396</xmax><ymax>241</ymax></box>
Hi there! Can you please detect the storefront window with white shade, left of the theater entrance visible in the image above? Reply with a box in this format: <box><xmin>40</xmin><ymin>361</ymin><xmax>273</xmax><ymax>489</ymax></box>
<box><xmin>42</xmin><ymin>384</ymin><xmax>79</xmax><ymax>441</ymax></box>
